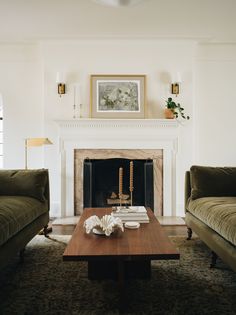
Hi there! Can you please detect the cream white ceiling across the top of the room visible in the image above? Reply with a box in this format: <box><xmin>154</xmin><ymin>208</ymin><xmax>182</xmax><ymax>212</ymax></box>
<box><xmin>0</xmin><ymin>0</ymin><xmax>236</xmax><ymax>43</ymax></box>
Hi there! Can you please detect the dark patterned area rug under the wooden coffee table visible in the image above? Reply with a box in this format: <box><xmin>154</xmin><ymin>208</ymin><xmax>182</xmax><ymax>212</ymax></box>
<box><xmin>0</xmin><ymin>235</ymin><xmax>236</xmax><ymax>315</ymax></box>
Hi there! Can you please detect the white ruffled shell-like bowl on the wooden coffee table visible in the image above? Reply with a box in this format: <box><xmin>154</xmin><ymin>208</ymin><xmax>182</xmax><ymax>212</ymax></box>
<box><xmin>84</xmin><ymin>214</ymin><xmax>124</xmax><ymax>236</ymax></box>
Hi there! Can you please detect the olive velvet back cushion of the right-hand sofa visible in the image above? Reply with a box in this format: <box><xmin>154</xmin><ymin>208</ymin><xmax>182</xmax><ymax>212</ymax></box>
<box><xmin>190</xmin><ymin>165</ymin><xmax>236</xmax><ymax>200</ymax></box>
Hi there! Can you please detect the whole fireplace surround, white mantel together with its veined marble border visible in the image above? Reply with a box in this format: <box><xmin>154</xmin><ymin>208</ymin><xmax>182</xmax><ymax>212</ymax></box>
<box><xmin>56</xmin><ymin>119</ymin><xmax>178</xmax><ymax>217</ymax></box>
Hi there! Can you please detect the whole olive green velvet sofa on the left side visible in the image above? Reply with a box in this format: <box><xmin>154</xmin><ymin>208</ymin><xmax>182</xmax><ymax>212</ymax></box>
<box><xmin>0</xmin><ymin>169</ymin><xmax>50</xmax><ymax>268</ymax></box>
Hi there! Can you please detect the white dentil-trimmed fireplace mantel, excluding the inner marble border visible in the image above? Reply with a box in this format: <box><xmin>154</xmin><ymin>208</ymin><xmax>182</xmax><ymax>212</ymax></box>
<box><xmin>55</xmin><ymin>119</ymin><xmax>179</xmax><ymax>217</ymax></box>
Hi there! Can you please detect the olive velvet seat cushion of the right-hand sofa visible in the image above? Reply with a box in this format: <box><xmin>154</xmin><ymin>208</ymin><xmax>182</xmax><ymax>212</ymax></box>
<box><xmin>187</xmin><ymin>197</ymin><xmax>236</xmax><ymax>246</ymax></box>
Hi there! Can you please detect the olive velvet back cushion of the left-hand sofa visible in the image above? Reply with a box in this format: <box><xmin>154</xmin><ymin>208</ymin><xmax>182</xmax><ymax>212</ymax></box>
<box><xmin>0</xmin><ymin>169</ymin><xmax>48</xmax><ymax>202</ymax></box>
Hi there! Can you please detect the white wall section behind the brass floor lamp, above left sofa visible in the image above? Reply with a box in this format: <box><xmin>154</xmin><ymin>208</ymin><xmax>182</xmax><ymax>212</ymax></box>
<box><xmin>0</xmin><ymin>44</ymin><xmax>43</xmax><ymax>169</ymax></box>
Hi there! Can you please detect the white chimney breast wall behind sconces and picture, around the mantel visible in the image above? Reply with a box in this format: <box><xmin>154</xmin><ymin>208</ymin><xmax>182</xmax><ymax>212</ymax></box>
<box><xmin>42</xmin><ymin>40</ymin><xmax>195</xmax><ymax>215</ymax></box>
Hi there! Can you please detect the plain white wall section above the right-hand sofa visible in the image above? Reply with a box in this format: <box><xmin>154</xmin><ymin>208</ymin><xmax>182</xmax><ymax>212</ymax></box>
<box><xmin>194</xmin><ymin>44</ymin><xmax>236</xmax><ymax>166</ymax></box>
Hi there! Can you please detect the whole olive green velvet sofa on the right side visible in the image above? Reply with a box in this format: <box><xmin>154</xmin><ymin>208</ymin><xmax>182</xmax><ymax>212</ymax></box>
<box><xmin>185</xmin><ymin>165</ymin><xmax>236</xmax><ymax>271</ymax></box>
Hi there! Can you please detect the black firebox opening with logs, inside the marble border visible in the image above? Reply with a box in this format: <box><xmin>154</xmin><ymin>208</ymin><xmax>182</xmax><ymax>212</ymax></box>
<box><xmin>83</xmin><ymin>158</ymin><xmax>154</xmax><ymax>209</ymax></box>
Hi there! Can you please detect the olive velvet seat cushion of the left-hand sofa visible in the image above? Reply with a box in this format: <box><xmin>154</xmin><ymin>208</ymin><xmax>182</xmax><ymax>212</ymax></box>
<box><xmin>0</xmin><ymin>196</ymin><xmax>48</xmax><ymax>246</ymax></box>
